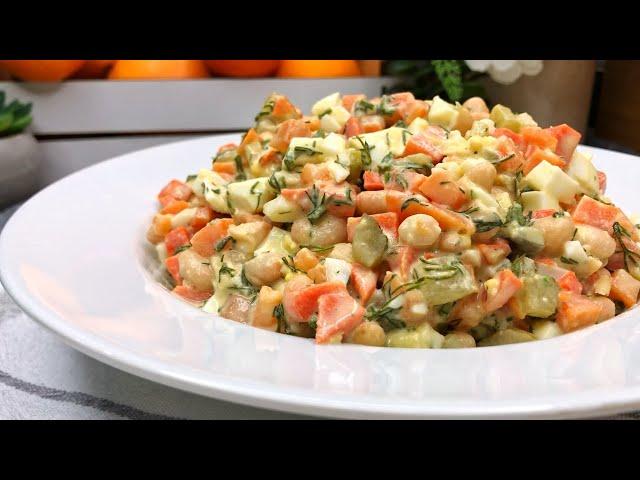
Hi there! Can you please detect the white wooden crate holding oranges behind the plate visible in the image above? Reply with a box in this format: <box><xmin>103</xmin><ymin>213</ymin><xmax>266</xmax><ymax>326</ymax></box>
<box><xmin>0</xmin><ymin>77</ymin><xmax>392</xmax><ymax>186</ymax></box>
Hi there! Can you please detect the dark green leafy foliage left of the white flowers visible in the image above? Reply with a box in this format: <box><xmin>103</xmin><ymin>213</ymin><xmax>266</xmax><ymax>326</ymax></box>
<box><xmin>382</xmin><ymin>60</ymin><xmax>486</xmax><ymax>102</ymax></box>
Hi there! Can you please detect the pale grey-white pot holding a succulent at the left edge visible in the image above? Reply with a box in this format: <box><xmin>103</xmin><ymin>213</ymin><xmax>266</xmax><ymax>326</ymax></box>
<box><xmin>0</xmin><ymin>133</ymin><xmax>41</xmax><ymax>208</ymax></box>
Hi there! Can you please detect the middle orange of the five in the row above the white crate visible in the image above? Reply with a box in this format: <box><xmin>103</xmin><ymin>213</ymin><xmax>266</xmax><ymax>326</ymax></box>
<box><xmin>109</xmin><ymin>60</ymin><xmax>209</xmax><ymax>80</ymax></box>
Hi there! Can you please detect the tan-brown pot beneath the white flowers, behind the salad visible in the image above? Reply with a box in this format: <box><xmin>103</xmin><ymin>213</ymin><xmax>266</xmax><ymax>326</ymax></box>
<box><xmin>483</xmin><ymin>60</ymin><xmax>596</xmax><ymax>137</ymax></box>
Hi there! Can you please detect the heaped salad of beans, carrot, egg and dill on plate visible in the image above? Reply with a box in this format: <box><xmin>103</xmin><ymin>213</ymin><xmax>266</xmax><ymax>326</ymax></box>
<box><xmin>147</xmin><ymin>93</ymin><xmax>640</xmax><ymax>348</ymax></box>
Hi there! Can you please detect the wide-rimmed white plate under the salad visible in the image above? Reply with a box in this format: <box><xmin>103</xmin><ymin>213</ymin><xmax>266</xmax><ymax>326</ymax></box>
<box><xmin>0</xmin><ymin>135</ymin><xmax>640</xmax><ymax>418</ymax></box>
